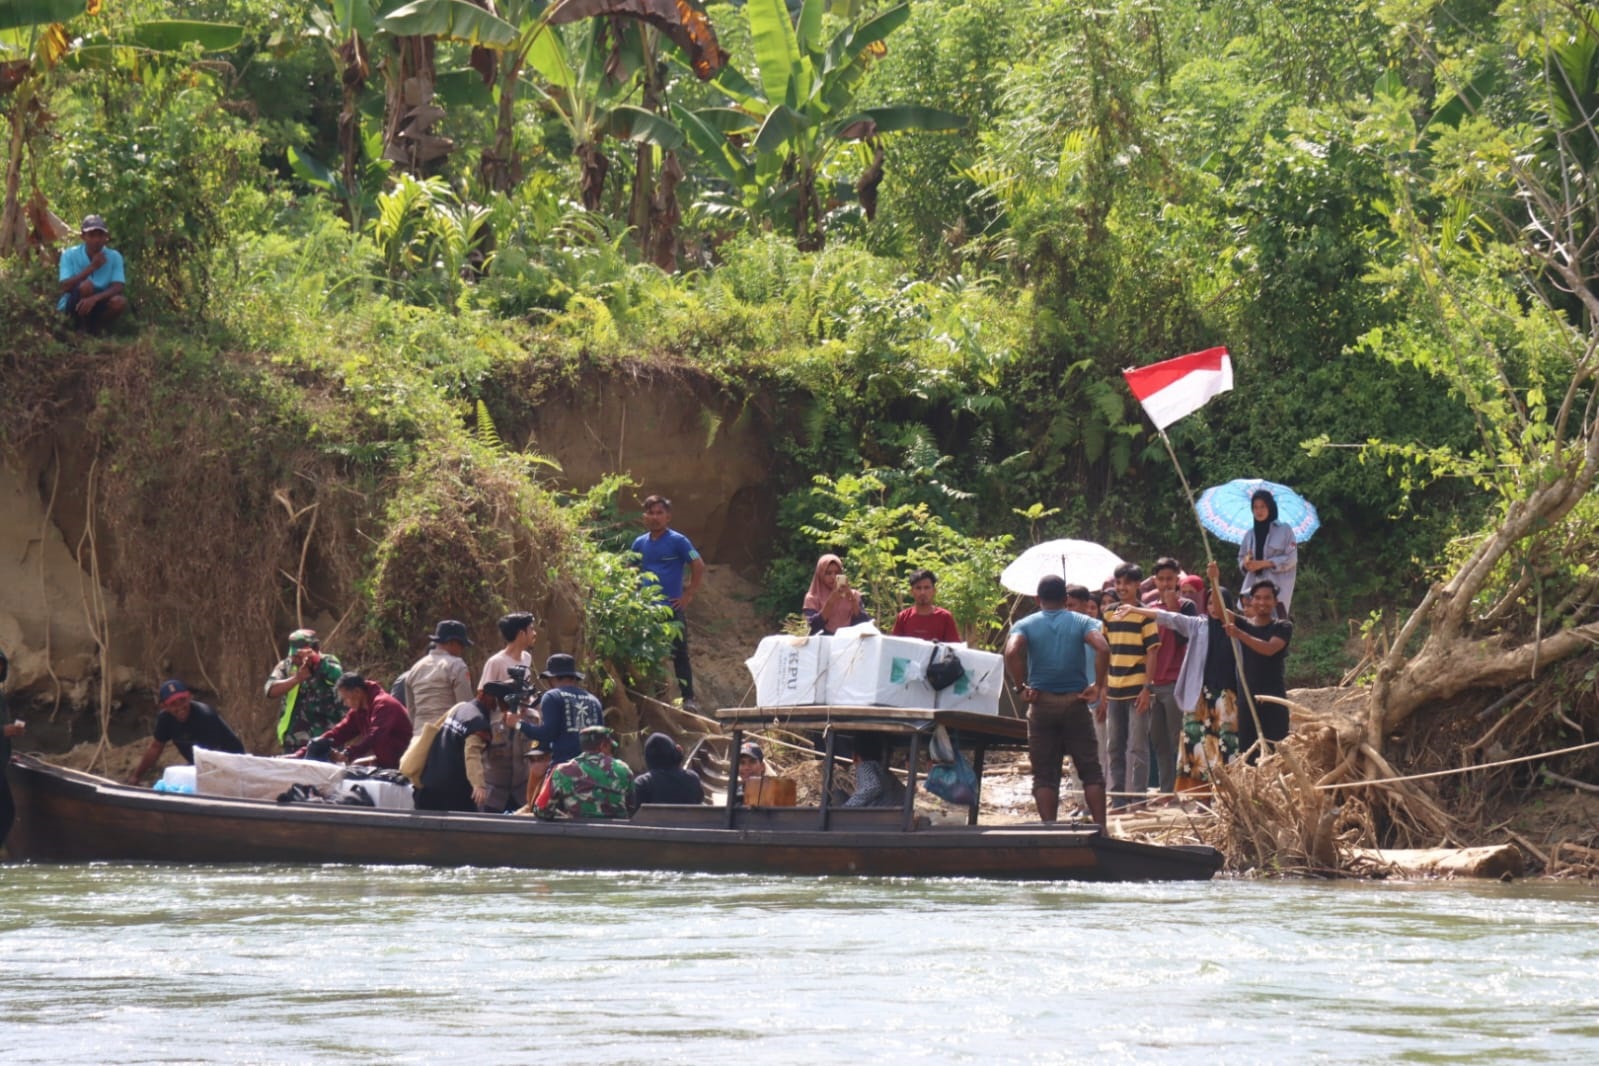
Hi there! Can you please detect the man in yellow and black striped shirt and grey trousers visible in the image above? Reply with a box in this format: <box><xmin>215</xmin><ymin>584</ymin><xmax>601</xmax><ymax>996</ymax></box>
<box><xmin>1100</xmin><ymin>563</ymin><xmax>1161</xmax><ymax>810</ymax></box>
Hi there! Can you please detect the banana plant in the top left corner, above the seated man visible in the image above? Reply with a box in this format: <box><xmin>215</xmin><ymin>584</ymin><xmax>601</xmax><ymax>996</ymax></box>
<box><xmin>0</xmin><ymin>0</ymin><xmax>243</xmax><ymax>256</ymax></box>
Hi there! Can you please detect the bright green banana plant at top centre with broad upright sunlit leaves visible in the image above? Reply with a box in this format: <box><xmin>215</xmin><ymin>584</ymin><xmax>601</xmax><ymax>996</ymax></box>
<box><xmin>673</xmin><ymin>0</ymin><xmax>966</xmax><ymax>251</ymax></box>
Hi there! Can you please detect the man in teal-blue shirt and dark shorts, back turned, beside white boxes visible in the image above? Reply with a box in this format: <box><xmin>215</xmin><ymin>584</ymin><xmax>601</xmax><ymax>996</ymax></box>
<box><xmin>1004</xmin><ymin>577</ymin><xmax>1110</xmax><ymax>829</ymax></box>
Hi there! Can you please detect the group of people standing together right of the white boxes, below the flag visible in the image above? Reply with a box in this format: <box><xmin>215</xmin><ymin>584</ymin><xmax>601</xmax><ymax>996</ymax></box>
<box><xmin>1004</xmin><ymin>489</ymin><xmax>1298</xmax><ymax>825</ymax></box>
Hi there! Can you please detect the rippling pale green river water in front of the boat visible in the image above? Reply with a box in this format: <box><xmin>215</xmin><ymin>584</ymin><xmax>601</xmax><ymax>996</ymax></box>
<box><xmin>0</xmin><ymin>865</ymin><xmax>1599</xmax><ymax>1066</ymax></box>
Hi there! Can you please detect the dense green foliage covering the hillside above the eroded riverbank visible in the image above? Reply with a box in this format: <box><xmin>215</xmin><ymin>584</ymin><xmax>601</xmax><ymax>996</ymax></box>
<box><xmin>12</xmin><ymin>0</ymin><xmax>1591</xmax><ymax>700</ymax></box>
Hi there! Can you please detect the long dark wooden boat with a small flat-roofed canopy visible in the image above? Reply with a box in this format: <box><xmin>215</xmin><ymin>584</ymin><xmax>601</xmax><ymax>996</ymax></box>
<box><xmin>8</xmin><ymin>708</ymin><xmax>1222</xmax><ymax>881</ymax></box>
